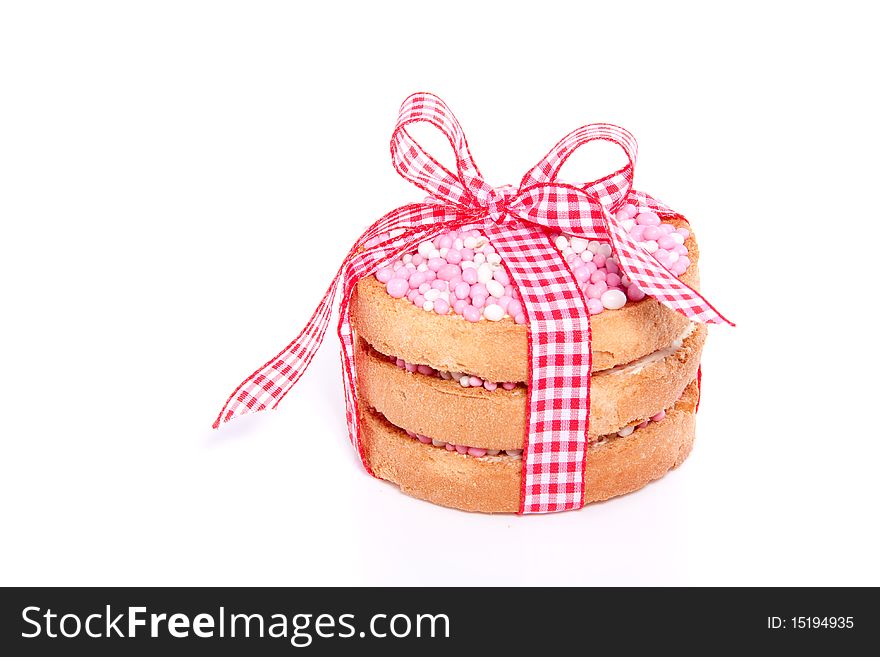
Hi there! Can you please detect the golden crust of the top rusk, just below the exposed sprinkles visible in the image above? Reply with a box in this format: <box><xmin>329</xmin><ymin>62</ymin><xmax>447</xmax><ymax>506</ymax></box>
<box><xmin>351</xmin><ymin>221</ymin><xmax>699</xmax><ymax>382</ymax></box>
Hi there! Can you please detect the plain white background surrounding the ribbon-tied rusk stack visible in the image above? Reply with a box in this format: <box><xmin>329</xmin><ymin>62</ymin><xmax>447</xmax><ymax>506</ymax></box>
<box><xmin>0</xmin><ymin>1</ymin><xmax>880</xmax><ymax>585</ymax></box>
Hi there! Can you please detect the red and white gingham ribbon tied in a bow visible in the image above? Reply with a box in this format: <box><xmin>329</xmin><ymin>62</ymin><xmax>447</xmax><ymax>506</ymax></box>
<box><xmin>214</xmin><ymin>93</ymin><xmax>729</xmax><ymax>513</ymax></box>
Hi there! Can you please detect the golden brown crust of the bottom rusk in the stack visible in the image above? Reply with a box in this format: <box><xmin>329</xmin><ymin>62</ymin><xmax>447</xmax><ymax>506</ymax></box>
<box><xmin>361</xmin><ymin>381</ymin><xmax>698</xmax><ymax>513</ymax></box>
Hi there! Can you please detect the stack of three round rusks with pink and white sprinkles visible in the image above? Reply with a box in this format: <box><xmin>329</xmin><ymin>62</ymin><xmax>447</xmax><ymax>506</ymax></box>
<box><xmin>351</xmin><ymin>206</ymin><xmax>706</xmax><ymax>513</ymax></box>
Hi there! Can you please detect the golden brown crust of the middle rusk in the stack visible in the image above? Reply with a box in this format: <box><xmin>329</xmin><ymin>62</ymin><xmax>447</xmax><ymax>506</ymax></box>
<box><xmin>355</xmin><ymin>325</ymin><xmax>706</xmax><ymax>449</ymax></box>
